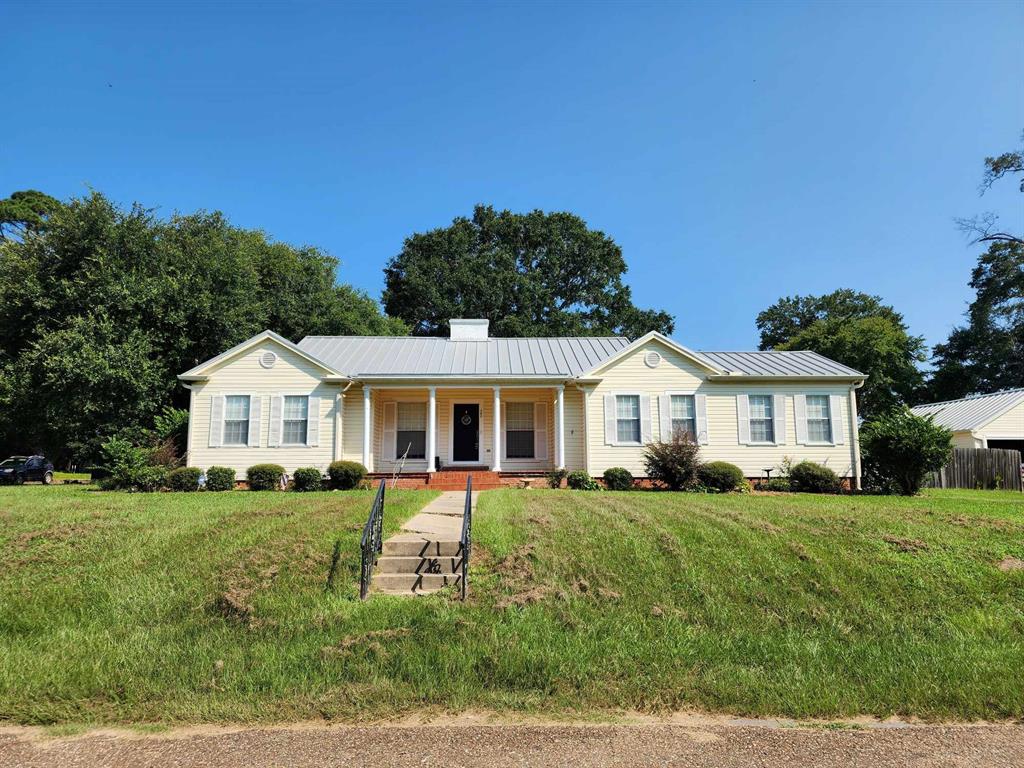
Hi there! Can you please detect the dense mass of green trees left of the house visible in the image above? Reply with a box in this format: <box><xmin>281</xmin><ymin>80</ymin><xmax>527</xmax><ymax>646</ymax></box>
<box><xmin>0</xmin><ymin>194</ymin><xmax>403</xmax><ymax>462</ymax></box>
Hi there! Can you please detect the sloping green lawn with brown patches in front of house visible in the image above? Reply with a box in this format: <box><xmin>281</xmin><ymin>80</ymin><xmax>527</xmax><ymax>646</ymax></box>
<box><xmin>0</xmin><ymin>486</ymin><xmax>1024</xmax><ymax>724</ymax></box>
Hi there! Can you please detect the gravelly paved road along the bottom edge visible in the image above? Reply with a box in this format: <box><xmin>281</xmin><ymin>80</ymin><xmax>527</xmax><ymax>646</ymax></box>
<box><xmin>0</xmin><ymin>724</ymin><xmax>1024</xmax><ymax>768</ymax></box>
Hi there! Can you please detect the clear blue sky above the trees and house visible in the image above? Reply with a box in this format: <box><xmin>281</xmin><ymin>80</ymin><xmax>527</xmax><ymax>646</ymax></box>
<box><xmin>0</xmin><ymin>0</ymin><xmax>1024</xmax><ymax>349</ymax></box>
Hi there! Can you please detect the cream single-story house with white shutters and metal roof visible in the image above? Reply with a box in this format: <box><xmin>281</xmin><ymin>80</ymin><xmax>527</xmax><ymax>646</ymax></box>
<box><xmin>178</xmin><ymin>319</ymin><xmax>864</xmax><ymax>486</ymax></box>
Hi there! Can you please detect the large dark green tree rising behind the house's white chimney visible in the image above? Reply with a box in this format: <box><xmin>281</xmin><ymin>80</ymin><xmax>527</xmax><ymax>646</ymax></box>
<box><xmin>383</xmin><ymin>206</ymin><xmax>673</xmax><ymax>338</ymax></box>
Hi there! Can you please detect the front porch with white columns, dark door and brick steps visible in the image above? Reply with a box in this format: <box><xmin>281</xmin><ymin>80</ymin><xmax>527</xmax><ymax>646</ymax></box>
<box><xmin>361</xmin><ymin>385</ymin><xmax>565</xmax><ymax>479</ymax></box>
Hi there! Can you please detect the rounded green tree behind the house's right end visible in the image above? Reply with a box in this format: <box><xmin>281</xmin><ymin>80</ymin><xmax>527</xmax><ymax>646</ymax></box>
<box><xmin>757</xmin><ymin>289</ymin><xmax>925</xmax><ymax>418</ymax></box>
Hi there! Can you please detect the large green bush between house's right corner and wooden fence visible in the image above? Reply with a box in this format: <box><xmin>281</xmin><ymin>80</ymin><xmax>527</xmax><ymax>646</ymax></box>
<box><xmin>860</xmin><ymin>408</ymin><xmax>952</xmax><ymax>496</ymax></box>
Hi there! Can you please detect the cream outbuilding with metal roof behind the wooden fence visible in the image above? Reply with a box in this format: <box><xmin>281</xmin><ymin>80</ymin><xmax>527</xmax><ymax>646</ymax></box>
<box><xmin>910</xmin><ymin>387</ymin><xmax>1024</xmax><ymax>456</ymax></box>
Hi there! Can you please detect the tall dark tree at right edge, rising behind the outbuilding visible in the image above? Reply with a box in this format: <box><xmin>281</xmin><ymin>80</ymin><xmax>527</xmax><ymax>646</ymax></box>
<box><xmin>928</xmin><ymin>133</ymin><xmax>1024</xmax><ymax>400</ymax></box>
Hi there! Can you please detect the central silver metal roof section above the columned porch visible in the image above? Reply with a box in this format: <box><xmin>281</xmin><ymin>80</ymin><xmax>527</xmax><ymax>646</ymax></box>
<box><xmin>299</xmin><ymin>336</ymin><xmax>629</xmax><ymax>378</ymax></box>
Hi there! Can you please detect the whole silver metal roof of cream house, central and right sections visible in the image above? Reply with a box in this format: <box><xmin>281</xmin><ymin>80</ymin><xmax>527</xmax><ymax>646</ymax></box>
<box><xmin>299</xmin><ymin>336</ymin><xmax>863</xmax><ymax>378</ymax></box>
